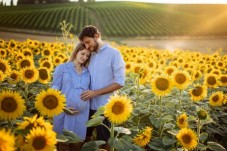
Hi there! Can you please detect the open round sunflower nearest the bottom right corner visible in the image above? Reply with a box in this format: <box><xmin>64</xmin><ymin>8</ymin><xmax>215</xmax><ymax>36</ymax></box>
<box><xmin>176</xmin><ymin>128</ymin><xmax>198</xmax><ymax>150</ymax></box>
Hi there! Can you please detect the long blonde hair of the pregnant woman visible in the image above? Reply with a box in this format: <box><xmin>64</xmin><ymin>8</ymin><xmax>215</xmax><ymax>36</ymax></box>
<box><xmin>68</xmin><ymin>43</ymin><xmax>90</xmax><ymax>67</ymax></box>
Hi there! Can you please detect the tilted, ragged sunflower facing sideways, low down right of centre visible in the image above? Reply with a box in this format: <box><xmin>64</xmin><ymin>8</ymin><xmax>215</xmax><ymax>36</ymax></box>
<box><xmin>132</xmin><ymin>126</ymin><xmax>152</xmax><ymax>147</ymax></box>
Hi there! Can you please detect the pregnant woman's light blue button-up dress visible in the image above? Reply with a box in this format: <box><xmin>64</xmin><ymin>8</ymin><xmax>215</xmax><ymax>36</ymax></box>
<box><xmin>52</xmin><ymin>62</ymin><xmax>90</xmax><ymax>140</ymax></box>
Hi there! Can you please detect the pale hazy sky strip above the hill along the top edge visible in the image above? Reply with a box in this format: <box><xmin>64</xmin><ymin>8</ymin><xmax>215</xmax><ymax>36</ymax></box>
<box><xmin>0</xmin><ymin>0</ymin><xmax>227</xmax><ymax>5</ymax></box>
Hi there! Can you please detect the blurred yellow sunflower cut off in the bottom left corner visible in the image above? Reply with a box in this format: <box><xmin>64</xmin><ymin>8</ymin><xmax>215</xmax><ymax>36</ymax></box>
<box><xmin>0</xmin><ymin>129</ymin><xmax>15</xmax><ymax>151</ymax></box>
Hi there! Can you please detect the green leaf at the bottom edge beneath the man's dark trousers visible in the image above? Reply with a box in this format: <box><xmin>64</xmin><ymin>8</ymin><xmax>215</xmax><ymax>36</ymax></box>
<box><xmin>80</xmin><ymin>141</ymin><xmax>106</xmax><ymax>151</ymax></box>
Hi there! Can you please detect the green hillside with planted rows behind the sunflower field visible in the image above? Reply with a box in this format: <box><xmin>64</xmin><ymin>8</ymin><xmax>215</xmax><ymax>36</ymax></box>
<box><xmin>0</xmin><ymin>2</ymin><xmax>227</xmax><ymax>37</ymax></box>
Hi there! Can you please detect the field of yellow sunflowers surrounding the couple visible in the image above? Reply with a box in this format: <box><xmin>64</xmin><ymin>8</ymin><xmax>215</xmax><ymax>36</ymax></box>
<box><xmin>0</xmin><ymin>36</ymin><xmax>227</xmax><ymax>151</ymax></box>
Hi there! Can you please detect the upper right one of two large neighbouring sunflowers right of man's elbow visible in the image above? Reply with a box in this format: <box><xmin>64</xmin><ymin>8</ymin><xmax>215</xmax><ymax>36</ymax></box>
<box><xmin>172</xmin><ymin>71</ymin><xmax>191</xmax><ymax>90</ymax></box>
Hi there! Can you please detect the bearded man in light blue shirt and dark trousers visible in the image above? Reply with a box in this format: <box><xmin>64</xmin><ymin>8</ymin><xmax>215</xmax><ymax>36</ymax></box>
<box><xmin>79</xmin><ymin>25</ymin><xmax>125</xmax><ymax>147</ymax></box>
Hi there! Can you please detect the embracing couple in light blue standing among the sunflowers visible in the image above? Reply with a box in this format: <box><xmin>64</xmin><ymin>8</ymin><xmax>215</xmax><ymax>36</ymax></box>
<box><xmin>52</xmin><ymin>25</ymin><xmax>125</xmax><ymax>150</ymax></box>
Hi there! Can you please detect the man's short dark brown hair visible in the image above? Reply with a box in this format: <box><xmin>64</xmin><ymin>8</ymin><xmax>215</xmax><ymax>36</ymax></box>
<box><xmin>79</xmin><ymin>25</ymin><xmax>101</xmax><ymax>40</ymax></box>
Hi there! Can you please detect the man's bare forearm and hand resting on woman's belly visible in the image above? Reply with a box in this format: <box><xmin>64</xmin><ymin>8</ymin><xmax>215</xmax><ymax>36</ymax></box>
<box><xmin>81</xmin><ymin>83</ymin><xmax>123</xmax><ymax>100</ymax></box>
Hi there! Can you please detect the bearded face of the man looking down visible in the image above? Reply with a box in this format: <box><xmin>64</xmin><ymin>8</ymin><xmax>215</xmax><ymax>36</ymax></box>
<box><xmin>82</xmin><ymin>37</ymin><xmax>99</xmax><ymax>52</ymax></box>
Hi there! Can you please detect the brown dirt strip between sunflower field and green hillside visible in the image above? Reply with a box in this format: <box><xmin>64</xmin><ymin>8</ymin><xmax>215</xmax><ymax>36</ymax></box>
<box><xmin>0</xmin><ymin>31</ymin><xmax>227</xmax><ymax>54</ymax></box>
